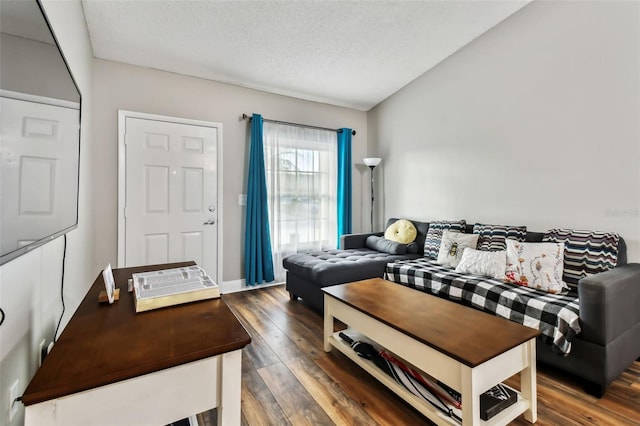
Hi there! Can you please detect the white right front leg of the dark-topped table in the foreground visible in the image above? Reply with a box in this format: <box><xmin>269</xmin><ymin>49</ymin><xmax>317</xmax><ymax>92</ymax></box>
<box><xmin>217</xmin><ymin>349</ymin><xmax>242</xmax><ymax>426</ymax></box>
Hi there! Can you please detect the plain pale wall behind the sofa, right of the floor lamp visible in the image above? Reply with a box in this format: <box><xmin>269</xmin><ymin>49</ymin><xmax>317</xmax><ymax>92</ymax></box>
<box><xmin>368</xmin><ymin>1</ymin><xmax>640</xmax><ymax>262</ymax></box>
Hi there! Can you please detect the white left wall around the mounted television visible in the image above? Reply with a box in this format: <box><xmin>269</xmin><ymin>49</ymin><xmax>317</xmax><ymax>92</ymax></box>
<box><xmin>0</xmin><ymin>0</ymin><xmax>99</xmax><ymax>425</ymax></box>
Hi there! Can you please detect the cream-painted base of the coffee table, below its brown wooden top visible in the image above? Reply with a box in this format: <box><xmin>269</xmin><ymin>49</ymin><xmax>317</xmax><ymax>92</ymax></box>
<box><xmin>324</xmin><ymin>283</ymin><xmax>537</xmax><ymax>426</ymax></box>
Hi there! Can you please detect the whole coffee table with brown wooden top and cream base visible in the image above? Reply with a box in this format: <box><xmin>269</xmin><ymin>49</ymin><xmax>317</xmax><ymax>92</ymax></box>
<box><xmin>322</xmin><ymin>278</ymin><xmax>540</xmax><ymax>425</ymax></box>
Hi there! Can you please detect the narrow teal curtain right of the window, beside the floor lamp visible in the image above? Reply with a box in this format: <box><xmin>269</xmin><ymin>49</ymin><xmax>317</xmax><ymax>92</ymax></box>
<box><xmin>338</xmin><ymin>128</ymin><xmax>352</xmax><ymax>248</ymax></box>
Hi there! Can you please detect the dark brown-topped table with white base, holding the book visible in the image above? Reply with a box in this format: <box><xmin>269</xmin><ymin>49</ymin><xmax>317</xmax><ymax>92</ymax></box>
<box><xmin>22</xmin><ymin>262</ymin><xmax>251</xmax><ymax>426</ymax></box>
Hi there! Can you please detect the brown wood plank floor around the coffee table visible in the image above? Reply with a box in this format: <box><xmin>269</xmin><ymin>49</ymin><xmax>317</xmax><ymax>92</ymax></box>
<box><xmin>198</xmin><ymin>286</ymin><xmax>640</xmax><ymax>426</ymax></box>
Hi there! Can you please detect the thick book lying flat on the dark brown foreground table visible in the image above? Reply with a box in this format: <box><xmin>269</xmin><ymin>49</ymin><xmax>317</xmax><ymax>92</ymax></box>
<box><xmin>131</xmin><ymin>266</ymin><xmax>220</xmax><ymax>312</ymax></box>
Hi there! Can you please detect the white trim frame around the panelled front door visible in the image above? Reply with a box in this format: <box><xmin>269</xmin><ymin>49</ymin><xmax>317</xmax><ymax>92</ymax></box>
<box><xmin>118</xmin><ymin>109</ymin><xmax>224</xmax><ymax>283</ymax></box>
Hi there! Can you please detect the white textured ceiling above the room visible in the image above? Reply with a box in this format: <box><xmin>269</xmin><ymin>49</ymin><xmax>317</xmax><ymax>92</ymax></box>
<box><xmin>82</xmin><ymin>0</ymin><xmax>529</xmax><ymax>111</ymax></box>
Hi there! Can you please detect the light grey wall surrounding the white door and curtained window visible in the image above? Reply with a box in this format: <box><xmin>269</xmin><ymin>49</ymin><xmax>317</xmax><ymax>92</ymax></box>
<box><xmin>93</xmin><ymin>60</ymin><xmax>369</xmax><ymax>282</ymax></box>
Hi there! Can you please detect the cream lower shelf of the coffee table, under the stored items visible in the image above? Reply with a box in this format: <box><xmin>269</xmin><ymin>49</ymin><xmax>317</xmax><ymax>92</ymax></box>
<box><xmin>329</xmin><ymin>333</ymin><xmax>529</xmax><ymax>425</ymax></box>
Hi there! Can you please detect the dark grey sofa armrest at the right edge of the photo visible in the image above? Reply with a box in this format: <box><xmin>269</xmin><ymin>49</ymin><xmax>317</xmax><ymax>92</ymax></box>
<box><xmin>578</xmin><ymin>263</ymin><xmax>640</xmax><ymax>345</ymax></box>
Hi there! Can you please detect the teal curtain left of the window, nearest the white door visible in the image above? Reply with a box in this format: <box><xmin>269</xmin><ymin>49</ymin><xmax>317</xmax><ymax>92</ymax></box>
<box><xmin>244</xmin><ymin>114</ymin><xmax>274</xmax><ymax>286</ymax></box>
